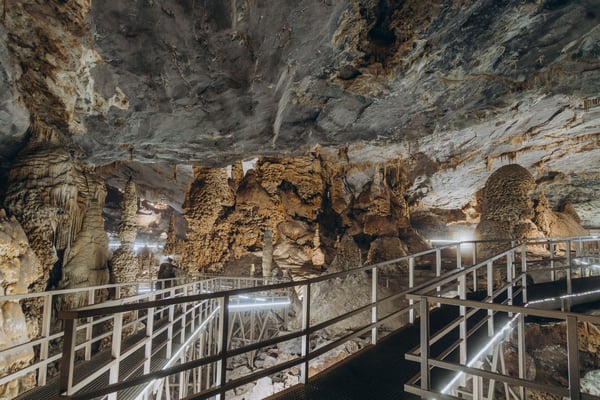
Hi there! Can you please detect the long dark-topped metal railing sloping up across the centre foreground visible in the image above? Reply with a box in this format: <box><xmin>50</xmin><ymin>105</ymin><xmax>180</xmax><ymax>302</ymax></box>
<box><xmin>60</xmin><ymin>243</ymin><xmax>478</xmax><ymax>399</ymax></box>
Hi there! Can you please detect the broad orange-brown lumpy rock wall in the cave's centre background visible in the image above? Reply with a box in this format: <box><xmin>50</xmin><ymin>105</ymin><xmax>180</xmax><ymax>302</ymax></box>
<box><xmin>170</xmin><ymin>149</ymin><xmax>427</xmax><ymax>271</ymax></box>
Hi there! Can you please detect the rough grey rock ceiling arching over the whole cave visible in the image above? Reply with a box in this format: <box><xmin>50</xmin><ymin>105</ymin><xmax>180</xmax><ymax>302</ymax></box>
<box><xmin>0</xmin><ymin>0</ymin><xmax>600</xmax><ymax>226</ymax></box>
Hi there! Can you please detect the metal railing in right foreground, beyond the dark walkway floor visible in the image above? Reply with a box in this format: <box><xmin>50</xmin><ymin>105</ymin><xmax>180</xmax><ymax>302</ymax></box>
<box><xmin>405</xmin><ymin>236</ymin><xmax>600</xmax><ymax>400</ymax></box>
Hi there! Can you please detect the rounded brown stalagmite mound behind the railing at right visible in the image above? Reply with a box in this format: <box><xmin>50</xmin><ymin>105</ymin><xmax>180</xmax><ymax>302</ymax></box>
<box><xmin>475</xmin><ymin>164</ymin><xmax>587</xmax><ymax>255</ymax></box>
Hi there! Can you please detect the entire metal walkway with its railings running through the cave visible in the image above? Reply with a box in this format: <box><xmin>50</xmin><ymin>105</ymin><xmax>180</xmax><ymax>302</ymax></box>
<box><xmin>0</xmin><ymin>237</ymin><xmax>600</xmax><ymax>400</ymax></box>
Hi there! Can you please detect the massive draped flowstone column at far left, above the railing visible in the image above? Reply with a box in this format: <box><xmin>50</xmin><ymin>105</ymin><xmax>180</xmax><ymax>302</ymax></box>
<box><xmin>5</xmin><ymin>131</ymin><xmax>108</xmax><ymax>292</ymax></box>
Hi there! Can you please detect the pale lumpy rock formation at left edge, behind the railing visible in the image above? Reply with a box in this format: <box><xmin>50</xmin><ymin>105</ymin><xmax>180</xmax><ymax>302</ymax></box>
<box><xmin>0</xmin><ymin>209</ymin><xmax>42</xmax><ymax>398</ymax></box>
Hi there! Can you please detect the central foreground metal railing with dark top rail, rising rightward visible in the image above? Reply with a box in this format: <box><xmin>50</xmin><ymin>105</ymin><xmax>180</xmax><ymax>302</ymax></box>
<box><xmin>60</xmin><ymin>243</ymin><xmax>478</xmax><ymax>399</ymax></box>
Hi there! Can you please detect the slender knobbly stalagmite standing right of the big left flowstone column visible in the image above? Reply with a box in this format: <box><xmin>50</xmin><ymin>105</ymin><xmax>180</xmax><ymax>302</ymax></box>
<box><xmin>111</xmin><ymin>180</ymin><xmax>140</xmax><ymax>283</ymax></box>
